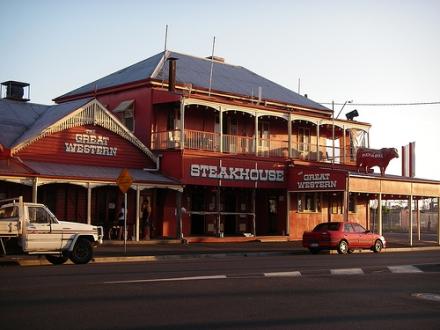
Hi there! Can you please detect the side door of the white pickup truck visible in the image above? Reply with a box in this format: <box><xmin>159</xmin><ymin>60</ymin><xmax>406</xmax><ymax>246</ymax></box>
<box><xmin>24</xmin><ymin>205</ymin><xmax>62</xmax><ymax>252</ymax></box>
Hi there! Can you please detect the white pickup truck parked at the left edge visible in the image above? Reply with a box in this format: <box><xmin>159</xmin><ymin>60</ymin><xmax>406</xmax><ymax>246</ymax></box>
<box><xmin>0</xmin><ymin>197</ymin><xmax>103</xmax><ymax>265</ymax></box>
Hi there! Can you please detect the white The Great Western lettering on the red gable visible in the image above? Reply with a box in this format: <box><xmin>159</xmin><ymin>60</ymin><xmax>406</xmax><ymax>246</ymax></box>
<box><xmin>64</xmin><ymin>130</ymin><xmax>118</xmax><ymax>156</ymax></box>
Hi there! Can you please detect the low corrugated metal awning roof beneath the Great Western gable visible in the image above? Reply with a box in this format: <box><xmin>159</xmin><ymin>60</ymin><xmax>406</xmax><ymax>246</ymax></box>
<box><xmin>23</xmin><ymin>161</ymin><xmax>180</xmax><ymax>186</ymax></box>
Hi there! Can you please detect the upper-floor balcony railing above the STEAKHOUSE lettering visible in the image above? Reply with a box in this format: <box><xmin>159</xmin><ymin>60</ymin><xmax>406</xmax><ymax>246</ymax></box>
<box><xmin>151</xmin><ymin>130</ymin><xmax>355</xmax><ymax>163</ymax></box>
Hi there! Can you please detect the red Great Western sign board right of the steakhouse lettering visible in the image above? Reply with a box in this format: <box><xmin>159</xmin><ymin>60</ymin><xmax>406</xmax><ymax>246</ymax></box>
<box><xmin>288</xmin><ymin>167</ymin><xmax>346</xmax><ymax>191</ymax></box>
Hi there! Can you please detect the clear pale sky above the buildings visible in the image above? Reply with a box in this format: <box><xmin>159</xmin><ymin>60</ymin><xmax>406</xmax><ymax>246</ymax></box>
<box><xmin>0</xmin><ymin>0</ymin><xmax>440</xmax><ymax>180</ymax></box>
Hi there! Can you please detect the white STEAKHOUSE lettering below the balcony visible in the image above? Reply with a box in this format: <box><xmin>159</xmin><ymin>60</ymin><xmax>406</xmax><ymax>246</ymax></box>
<box><xmin>190</xmin><ymin>164</ymin><xmax>284</xmax><ymax>182</ymax></box>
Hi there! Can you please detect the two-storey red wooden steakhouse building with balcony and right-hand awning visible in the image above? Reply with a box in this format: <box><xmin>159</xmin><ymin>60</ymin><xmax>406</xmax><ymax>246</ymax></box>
<box><xmin>1</xmin><ymin>51</ymin><xmax>440</xmax><ymax>240</ymax></box>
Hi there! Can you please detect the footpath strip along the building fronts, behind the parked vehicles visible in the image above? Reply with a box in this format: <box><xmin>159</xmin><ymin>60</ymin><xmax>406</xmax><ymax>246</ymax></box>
<box><xmin>0</xmin><ymin>240</ymin><xmax>440</xmax><ymax>266</ymax></box>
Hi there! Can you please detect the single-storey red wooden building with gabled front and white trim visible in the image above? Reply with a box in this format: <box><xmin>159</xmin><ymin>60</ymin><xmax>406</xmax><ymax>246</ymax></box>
<box><xmin>0</xmin><ymin>94</ymin><xmax>182</xmax><ymax>237</ymax></box>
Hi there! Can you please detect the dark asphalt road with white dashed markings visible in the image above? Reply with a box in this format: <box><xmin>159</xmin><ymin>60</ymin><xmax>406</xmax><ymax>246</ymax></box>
<box><xmin>0</xmin><ymin>252</ymin><xmax>440</xmax><ymax>329</ymax></box>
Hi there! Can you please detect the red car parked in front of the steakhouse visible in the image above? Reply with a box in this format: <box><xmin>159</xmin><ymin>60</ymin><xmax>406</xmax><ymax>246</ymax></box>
<box><xmin>303</xmin><ymin>222</ymin><xmax>385</xmax><ymax>254</ymax></box>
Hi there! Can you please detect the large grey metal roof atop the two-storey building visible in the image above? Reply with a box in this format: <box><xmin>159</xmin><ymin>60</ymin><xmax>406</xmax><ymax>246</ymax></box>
<box><xmin>55</xmin><ymin>51</ymin><xmax>331</xmax><ymax>111</ymax></box>
